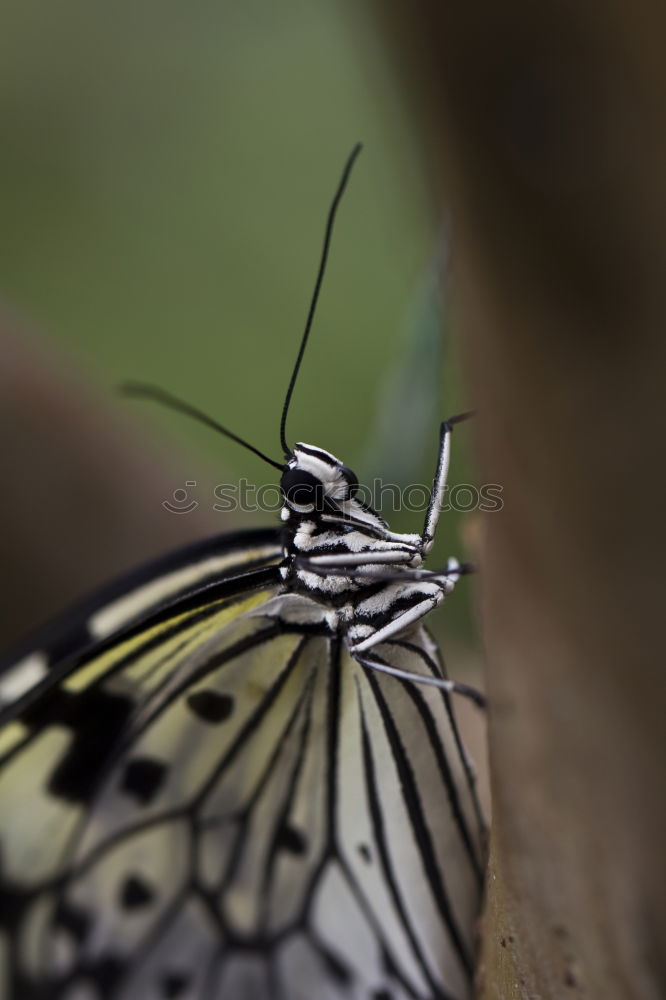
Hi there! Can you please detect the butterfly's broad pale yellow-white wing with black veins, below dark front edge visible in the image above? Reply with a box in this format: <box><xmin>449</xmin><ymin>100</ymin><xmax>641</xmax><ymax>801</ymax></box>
<box><xmin>0</xmin><ymin>587</ymin><xmax>481</xmax><ymax>1000</ymax></box>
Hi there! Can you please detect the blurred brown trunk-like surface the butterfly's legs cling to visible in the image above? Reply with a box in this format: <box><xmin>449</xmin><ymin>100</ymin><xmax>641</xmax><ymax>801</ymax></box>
<box><xmin>378</xmin><ymin>0</ymin><xmax>666</xmax><ymax>1000</ymax></box>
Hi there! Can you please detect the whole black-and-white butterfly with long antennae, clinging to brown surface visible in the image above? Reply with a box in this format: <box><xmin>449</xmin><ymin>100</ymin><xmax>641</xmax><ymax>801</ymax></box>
<box><xmin>0</xmin><ymin>146</ymin><xmax>485</xmax><ymax>1000</ymax></box>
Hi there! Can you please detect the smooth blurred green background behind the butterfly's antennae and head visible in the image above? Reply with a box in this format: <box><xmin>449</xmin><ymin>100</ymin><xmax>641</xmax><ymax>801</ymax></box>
<box><xmin>0</xmin><ymin>0</ymin><xmax>478</xmax><ymax>640</ymax></box>
